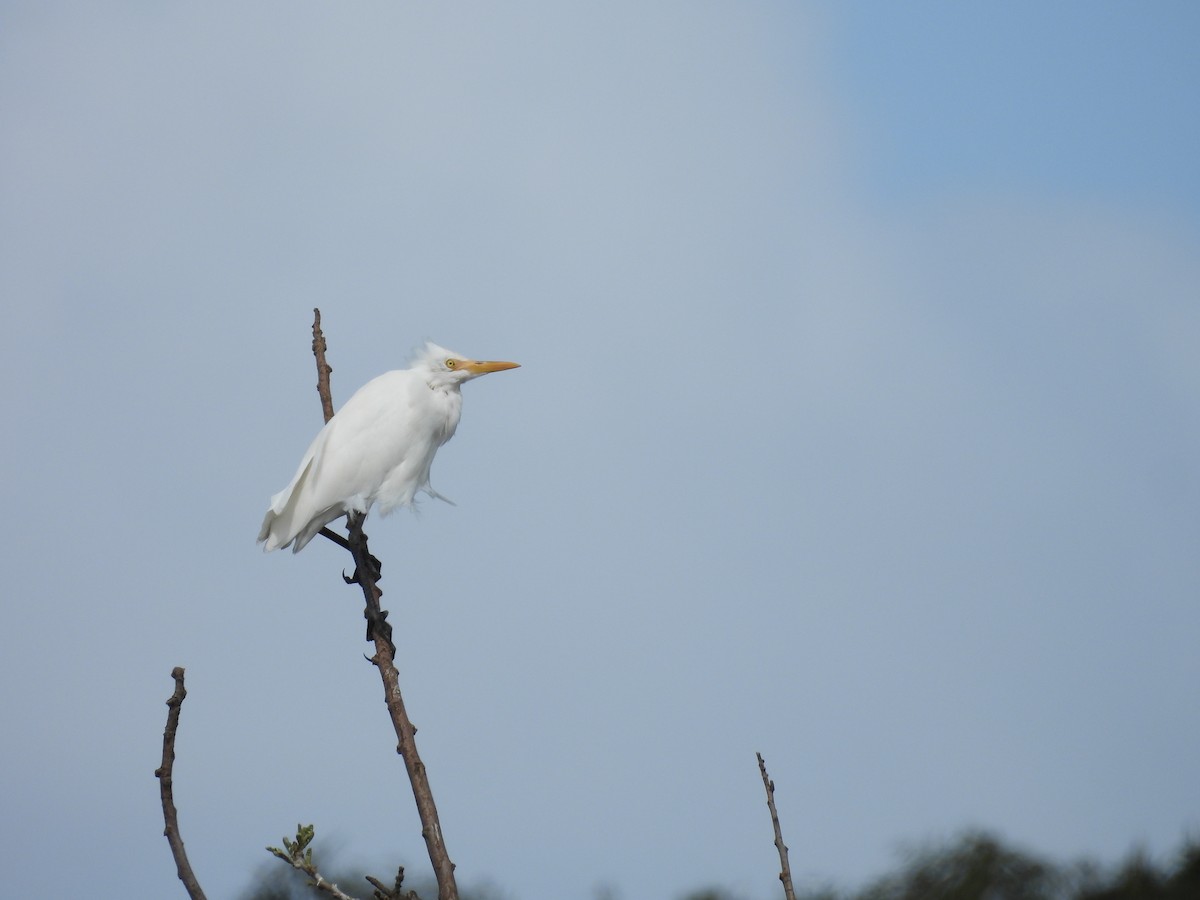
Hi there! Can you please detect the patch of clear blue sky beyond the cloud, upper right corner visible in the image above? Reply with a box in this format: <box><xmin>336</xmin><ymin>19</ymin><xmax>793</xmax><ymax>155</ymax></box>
<box><xmin>824</xmin><ymin>2</ymin><xmax>1200</xmax><ymax>214</ymax></box>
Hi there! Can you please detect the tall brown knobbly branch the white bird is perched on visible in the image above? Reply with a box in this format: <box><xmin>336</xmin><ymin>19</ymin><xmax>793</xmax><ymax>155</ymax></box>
<box><xmin>312</xmin><ymin>310</ymin><xmax>458</xmax><ymax>900</ymax></box>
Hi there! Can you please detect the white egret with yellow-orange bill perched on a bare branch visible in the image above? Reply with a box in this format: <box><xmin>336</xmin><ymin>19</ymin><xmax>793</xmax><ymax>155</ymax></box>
<box><xmin>258</xmin><ymin>343</ymin><xmax>517</xmax><ymax>553</ymax></box>
